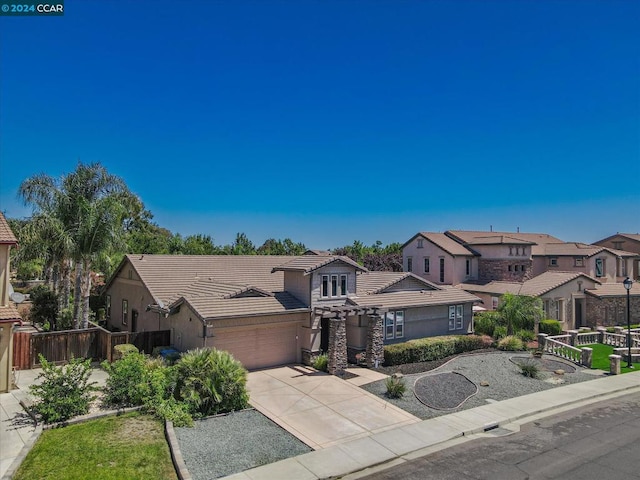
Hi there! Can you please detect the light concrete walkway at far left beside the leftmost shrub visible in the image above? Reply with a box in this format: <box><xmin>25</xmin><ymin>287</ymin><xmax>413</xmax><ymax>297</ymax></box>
<box><xmin>0</xmin><ymin>368</ymin><xmax>107</xmax><ymax>478</ymax></box>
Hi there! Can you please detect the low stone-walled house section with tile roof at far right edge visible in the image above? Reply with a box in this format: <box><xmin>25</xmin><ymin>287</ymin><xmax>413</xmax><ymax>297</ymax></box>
<box><xmin>585</xmin><ymin>281</ymin><xmax>640</xmax><ymax>327</ymax></box>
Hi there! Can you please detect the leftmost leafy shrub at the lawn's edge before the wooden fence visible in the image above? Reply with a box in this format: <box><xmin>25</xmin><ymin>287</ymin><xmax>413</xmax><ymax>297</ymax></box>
<box><xmin>30</xmin><ymin>355</ymin><xmax>97</xmax><ymax>423</ymax></box>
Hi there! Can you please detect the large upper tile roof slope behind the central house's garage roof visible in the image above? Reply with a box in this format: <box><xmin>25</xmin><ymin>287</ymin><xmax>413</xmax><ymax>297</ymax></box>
<box><xmin>123</xmin><ymin>254</ymin><xmax>292</xmax><ymax>306</ymax></box>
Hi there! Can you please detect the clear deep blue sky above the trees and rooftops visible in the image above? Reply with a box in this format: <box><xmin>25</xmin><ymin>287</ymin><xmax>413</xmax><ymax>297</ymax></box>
<box><xmin>0</xmin><ymin>0</ymin><xmax>640</xmax><ymax>248</ymax></box>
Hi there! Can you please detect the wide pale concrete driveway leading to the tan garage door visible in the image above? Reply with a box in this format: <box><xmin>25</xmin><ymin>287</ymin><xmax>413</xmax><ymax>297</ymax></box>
<box><xmin>247</xmin><ymin>365</ymin><xmax>420</xmax><ymax>450</ymax></box>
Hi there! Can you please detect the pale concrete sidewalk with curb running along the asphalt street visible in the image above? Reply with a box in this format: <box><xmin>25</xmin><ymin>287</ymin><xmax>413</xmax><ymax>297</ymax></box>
<box><xmin>225</xmin><ymin>372</ymin><xmax>640</xmax><ymax>480</ymax></box>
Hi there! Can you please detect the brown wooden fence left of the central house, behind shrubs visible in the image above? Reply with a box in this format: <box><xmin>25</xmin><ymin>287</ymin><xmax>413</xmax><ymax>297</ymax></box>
<box><xmin>13</xmin><ymin>326</ymin><xmax>171</xmax><ymax>370</ymax></box>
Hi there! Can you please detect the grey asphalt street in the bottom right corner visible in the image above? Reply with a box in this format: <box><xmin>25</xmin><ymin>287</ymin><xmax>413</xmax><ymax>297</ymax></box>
<box><xmin>362</xmin><ymin>394</ymin><xmax>640</xmax><ymax>480</ymax></box>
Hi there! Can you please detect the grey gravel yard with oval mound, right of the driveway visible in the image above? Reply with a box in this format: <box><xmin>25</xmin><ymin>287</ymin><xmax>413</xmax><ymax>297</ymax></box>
<box><xmin>362</xmin><ymin>352</ymin><xmax>596</xmax><ymax>419</ymax></box>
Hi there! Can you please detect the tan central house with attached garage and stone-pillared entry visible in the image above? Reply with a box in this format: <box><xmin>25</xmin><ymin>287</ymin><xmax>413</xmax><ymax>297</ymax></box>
<box><xmin>105</xmin><ymin>252</ymin><xmax>479</xmax><ymax>369</ymax></box>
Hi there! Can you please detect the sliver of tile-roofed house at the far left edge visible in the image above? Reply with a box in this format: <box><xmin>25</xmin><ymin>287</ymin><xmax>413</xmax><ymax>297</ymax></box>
<box><xmin>0</xmin><ymin>212</ymin><xmax>21</xmax><ymax>393</ymax></box>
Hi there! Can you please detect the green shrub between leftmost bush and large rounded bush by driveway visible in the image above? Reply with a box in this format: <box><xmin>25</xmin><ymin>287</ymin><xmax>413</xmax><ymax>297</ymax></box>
<box><xmin>102</xmin><ymin>350</ymin><xmax>148</xmax><ymax>407</ymax></box>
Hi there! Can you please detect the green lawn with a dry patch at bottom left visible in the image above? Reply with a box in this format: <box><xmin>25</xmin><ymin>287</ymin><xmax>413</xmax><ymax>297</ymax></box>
<box><xmin>13</xmin><ymin>413</ymin><xmax>177</xmax><ymax>480</ymax></box>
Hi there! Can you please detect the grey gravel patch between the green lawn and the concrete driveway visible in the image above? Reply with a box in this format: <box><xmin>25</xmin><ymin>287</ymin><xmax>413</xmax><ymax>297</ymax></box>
<box><xmin>175</xmin><ymin>409</ymin><xmax>312</xmax><ymax>480</ymax></box>
